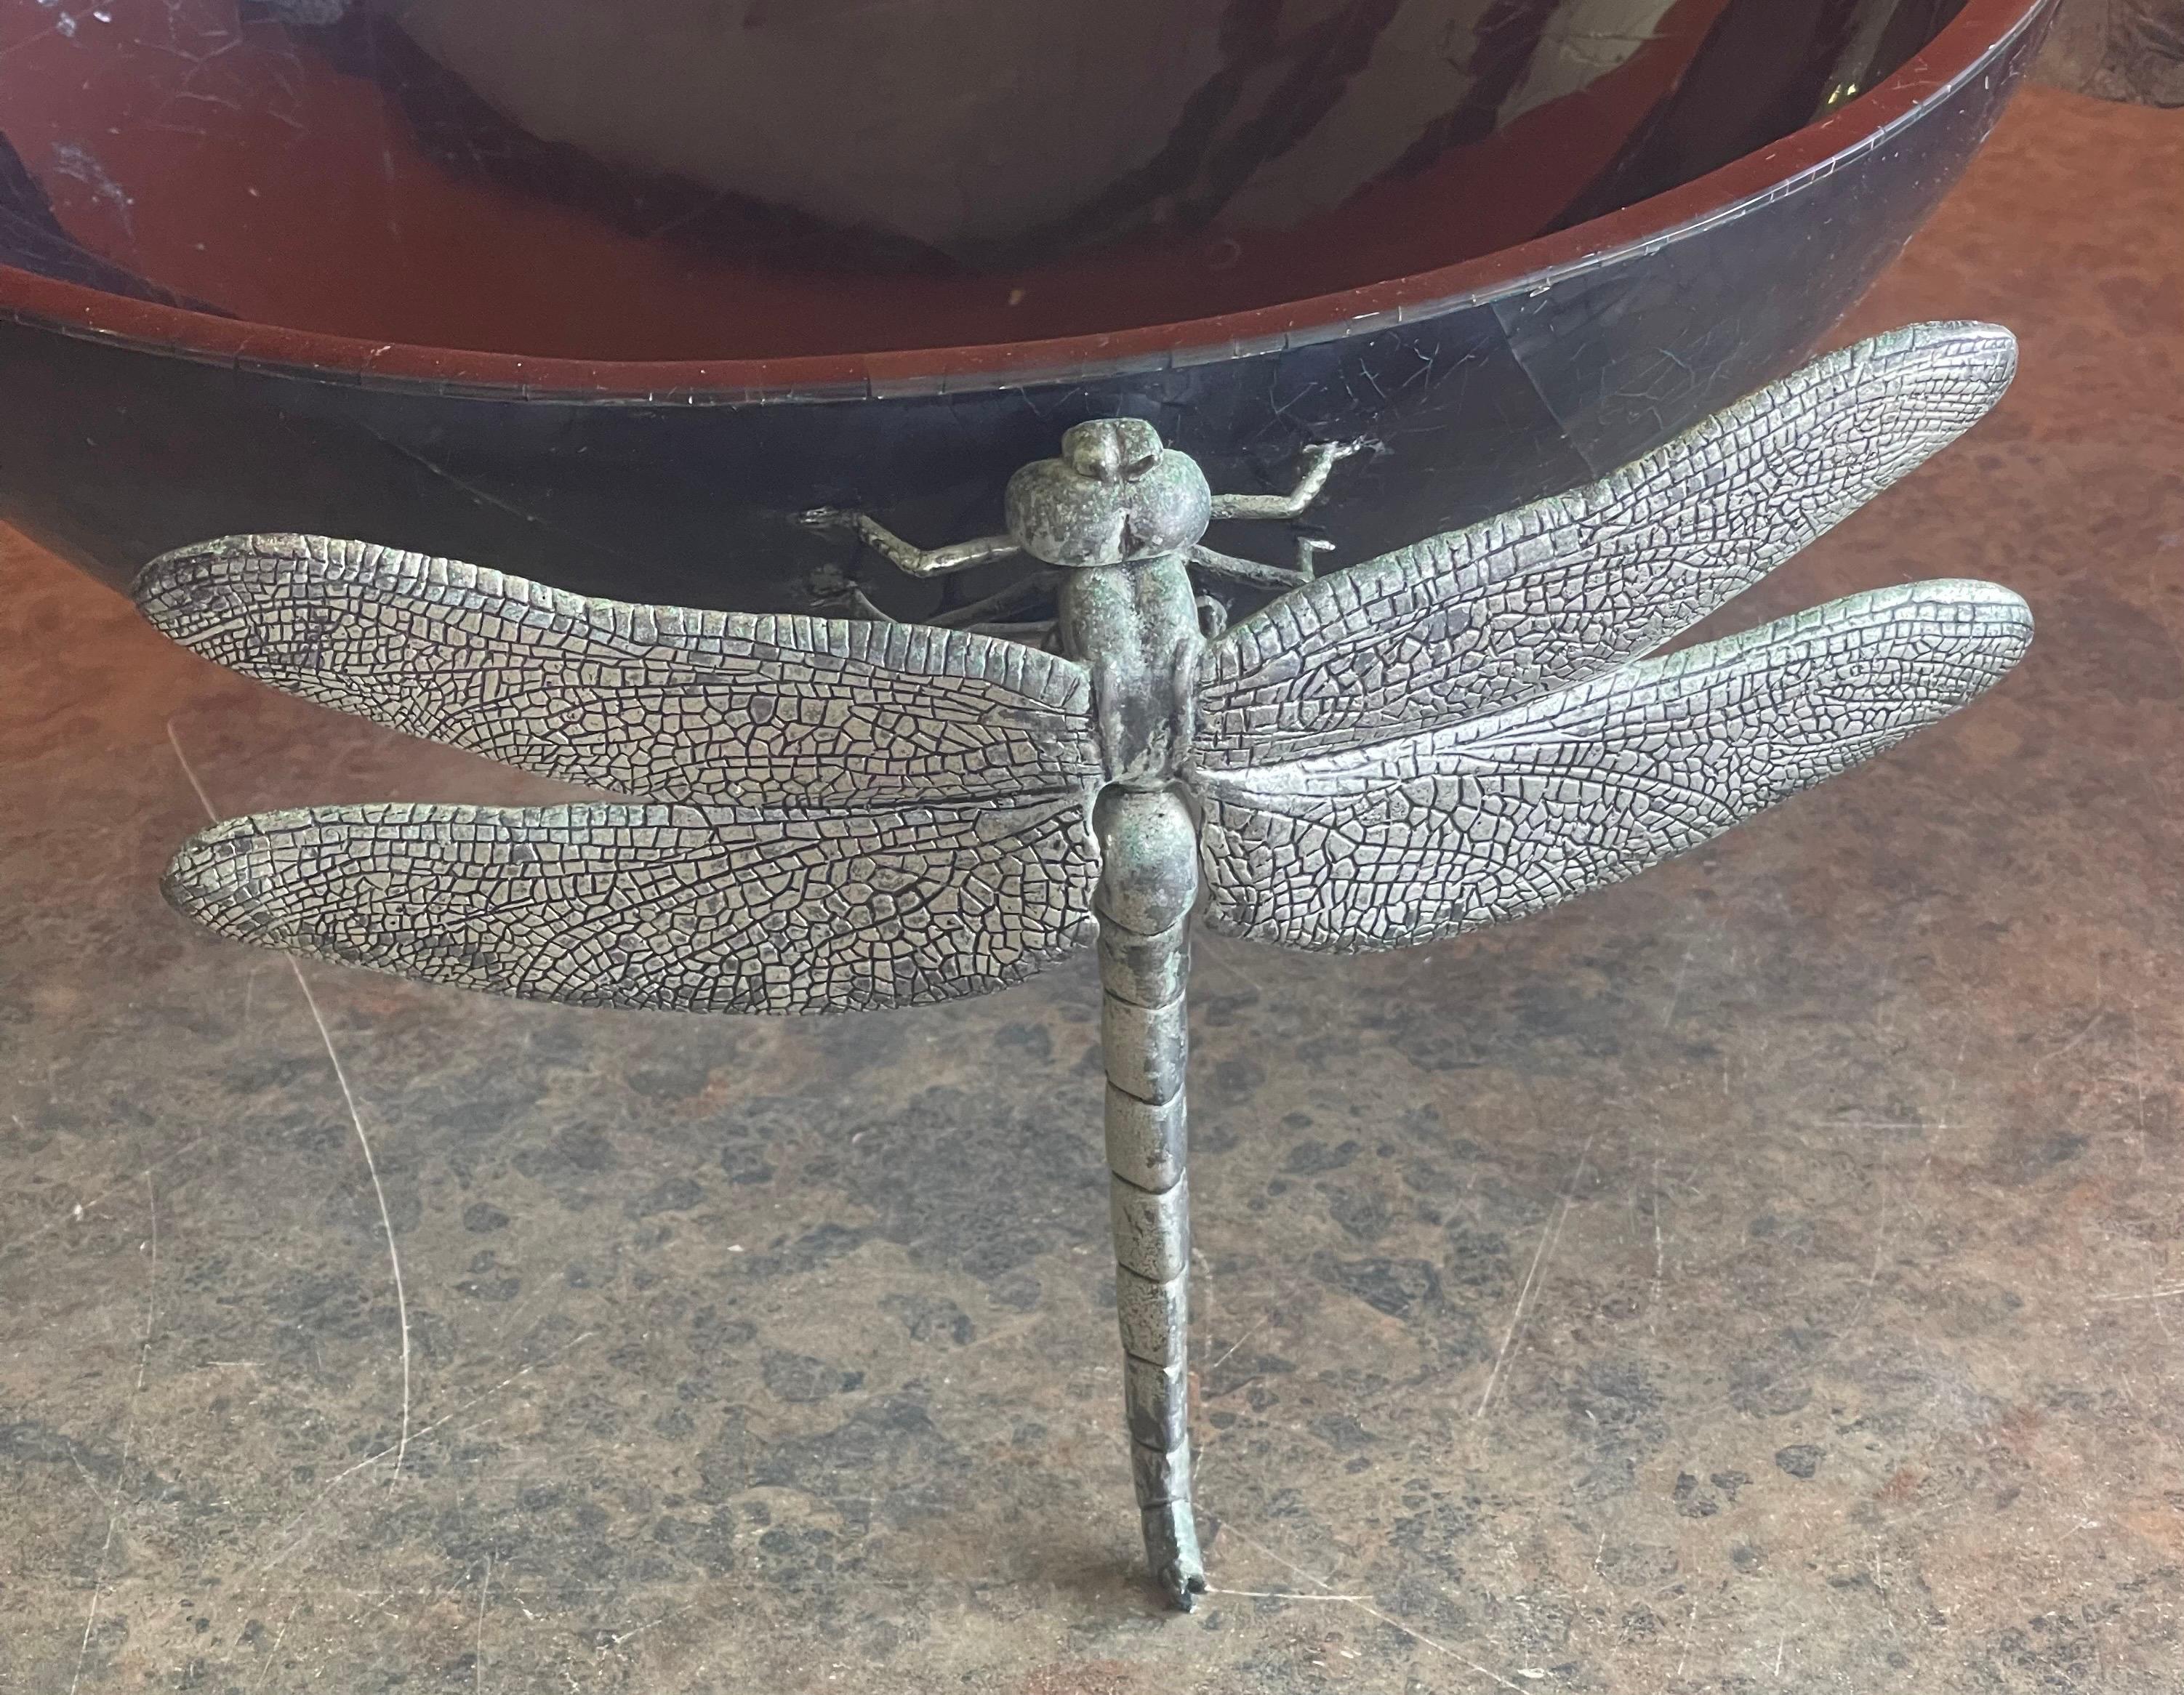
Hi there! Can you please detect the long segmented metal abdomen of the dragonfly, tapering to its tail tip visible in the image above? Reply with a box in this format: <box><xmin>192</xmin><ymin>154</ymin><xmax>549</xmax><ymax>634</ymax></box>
<box><xmin>1092</xmin><ymin>786</ymin><xmax>1205</xmax><ymax>1612</ymax></box>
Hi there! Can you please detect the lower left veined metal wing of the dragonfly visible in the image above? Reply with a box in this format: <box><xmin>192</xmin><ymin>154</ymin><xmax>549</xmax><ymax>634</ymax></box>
<box><xmin>166</xmin><ymin>795</ymin><xmax>1099</xmax><ymax>1013</ymax></box>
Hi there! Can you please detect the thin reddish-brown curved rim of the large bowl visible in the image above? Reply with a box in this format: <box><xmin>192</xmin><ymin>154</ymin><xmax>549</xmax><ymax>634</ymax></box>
<box><xmin>0</xmin><ymin>0</ymin><xmax>2060</xmax><ymax>404</ymax></box>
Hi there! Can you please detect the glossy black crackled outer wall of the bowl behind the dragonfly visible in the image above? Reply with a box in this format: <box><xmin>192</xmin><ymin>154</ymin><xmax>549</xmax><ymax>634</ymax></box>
<box><xmin>0</xmin><ymin>0</ymin><xmax>2051</xmax><ymax>616</ymax></box>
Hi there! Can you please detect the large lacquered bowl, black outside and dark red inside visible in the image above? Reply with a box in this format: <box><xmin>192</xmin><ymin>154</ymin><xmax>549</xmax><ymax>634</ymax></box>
<box><xmin>0</xmin><ymin>0</ymin><xmax>2053</xmax><ymax>613</ymax></box>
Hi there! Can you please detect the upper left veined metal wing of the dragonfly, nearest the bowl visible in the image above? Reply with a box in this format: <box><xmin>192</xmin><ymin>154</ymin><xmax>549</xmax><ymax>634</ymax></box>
<box><xmin>135</xmin><ymin>535</ymin><xmax>1101</xmax><ymax>808</ymax></box>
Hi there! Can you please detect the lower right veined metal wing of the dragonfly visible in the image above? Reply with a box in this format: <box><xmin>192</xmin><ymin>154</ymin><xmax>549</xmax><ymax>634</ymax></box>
<box><xmin>1197</xmin><ymin>581</ymin><xmax>2031</xmax><ymax>952</ymax></box>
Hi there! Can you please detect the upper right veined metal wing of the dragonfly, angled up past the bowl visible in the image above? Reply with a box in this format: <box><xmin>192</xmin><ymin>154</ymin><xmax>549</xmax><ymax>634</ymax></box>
<box><xmin>1195</xmin><ymin>323</ymin><xmax>2016</xmax><ymax>771</ymax></box>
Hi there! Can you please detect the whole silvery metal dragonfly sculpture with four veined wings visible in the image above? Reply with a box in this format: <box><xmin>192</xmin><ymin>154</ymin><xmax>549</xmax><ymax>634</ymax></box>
<box><xmin>137</xmin><ymin>323</ymin><xmax>2031</xmax><ymax>1608</ymax></box>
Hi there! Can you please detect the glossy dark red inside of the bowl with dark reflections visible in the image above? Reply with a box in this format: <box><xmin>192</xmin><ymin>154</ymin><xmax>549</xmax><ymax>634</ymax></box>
<box><xmin>0</xmin><ymin>0</ymin><xmax>1964</xmax><ymax>361</ymax></box>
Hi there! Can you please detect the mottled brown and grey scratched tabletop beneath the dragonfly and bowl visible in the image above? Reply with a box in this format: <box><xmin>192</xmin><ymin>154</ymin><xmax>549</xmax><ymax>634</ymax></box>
<box><xmin>0</xmin><ymin>89</ymin><xmax>2184</xmax><ymax>1695</ymax></box>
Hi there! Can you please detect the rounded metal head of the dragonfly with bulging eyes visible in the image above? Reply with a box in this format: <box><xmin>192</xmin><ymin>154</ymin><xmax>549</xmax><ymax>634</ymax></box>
<box><xmin>1009</xmin><ymin>417</ymin><xmax>1212</xmax><ymax>568</ymax></box>
